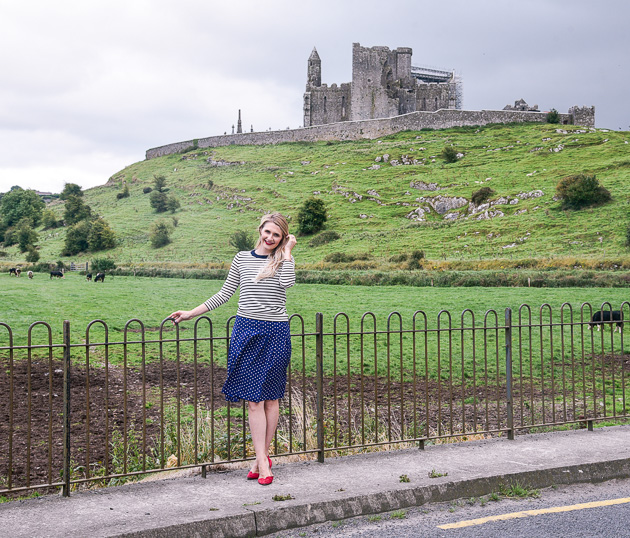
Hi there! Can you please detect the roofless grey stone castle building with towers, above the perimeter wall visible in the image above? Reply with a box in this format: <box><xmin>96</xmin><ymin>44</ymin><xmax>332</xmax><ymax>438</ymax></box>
<box><xmin>304</xmin><ymin>43</ymin><xmax>462</xmax><ymax>127</ymax></box>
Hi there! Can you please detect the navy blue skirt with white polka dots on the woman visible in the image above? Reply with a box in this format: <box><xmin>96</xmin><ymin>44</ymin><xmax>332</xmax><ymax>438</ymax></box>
<box><xmin>221</xmin><ymin>316</ymin><xmax>291</xmax><ymax>402</ymax></box>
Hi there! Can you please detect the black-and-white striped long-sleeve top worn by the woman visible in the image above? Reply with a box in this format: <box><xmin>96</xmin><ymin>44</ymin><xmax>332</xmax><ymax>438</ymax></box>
<box><xmin>204</xmin><ymin>250</ymin><xmax>295</xmax><ymax>321</ymax></box>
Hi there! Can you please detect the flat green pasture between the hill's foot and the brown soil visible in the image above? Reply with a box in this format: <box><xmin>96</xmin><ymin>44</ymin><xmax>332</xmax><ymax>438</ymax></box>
<box><xmin>0</xmin><ymin>273</ymin><xmax>630</xmax><ymax>375</ymax></box>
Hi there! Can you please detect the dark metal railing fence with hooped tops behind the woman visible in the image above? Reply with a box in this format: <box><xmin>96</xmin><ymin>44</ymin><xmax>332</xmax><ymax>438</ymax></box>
<box><xmin>0</xmin><ymin>302</ymin><xmax>630</xmax><ymax>495</ymax></box>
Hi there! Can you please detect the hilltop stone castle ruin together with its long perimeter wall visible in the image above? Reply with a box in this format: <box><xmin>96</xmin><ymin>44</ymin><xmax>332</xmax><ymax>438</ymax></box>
<box><xmin>146</xmin><ymin>43</ymin><xmax>595</xmax><ymax>159</ymax></box>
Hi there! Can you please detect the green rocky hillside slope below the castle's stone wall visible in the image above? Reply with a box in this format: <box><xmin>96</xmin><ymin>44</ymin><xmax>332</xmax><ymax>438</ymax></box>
<box><xmin>5</xmin><ymin>124</ymin><xmax>630</xmax><ymax>268</ymax></box>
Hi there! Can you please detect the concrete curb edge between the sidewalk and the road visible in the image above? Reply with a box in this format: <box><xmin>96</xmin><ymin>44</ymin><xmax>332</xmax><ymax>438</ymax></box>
<box><xmin>119</xmin><ymin>452</ymin><xmax>630</xmax><ymax>538</ymax></box>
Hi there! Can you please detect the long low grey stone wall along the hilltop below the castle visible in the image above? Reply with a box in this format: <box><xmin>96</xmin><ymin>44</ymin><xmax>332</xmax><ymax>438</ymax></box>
<box><xmin>146</xmin><ymin>107</ymin><xmax>595</xmax><ymax>159</ymax></box>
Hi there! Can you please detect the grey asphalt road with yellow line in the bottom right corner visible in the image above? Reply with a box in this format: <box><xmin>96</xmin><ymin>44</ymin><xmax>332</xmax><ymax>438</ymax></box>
<box><xmin>273</xmin><ymin>479</ymin><xmax>630</xmax><ymax>538</ymax></box>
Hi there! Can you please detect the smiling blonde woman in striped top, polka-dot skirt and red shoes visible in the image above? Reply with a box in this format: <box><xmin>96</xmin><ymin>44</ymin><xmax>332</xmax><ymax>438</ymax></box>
<box><xmin>170</xmin><ymin>213</ymin><xmax>296</xmax><ymax>486</ymax></box>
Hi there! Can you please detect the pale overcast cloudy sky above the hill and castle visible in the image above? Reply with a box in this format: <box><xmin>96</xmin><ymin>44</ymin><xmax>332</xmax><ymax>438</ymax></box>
<box><xmin>0</xmin><ymin>0</ymin><xmax>630</xmax><ymax>192</ymax></box>
